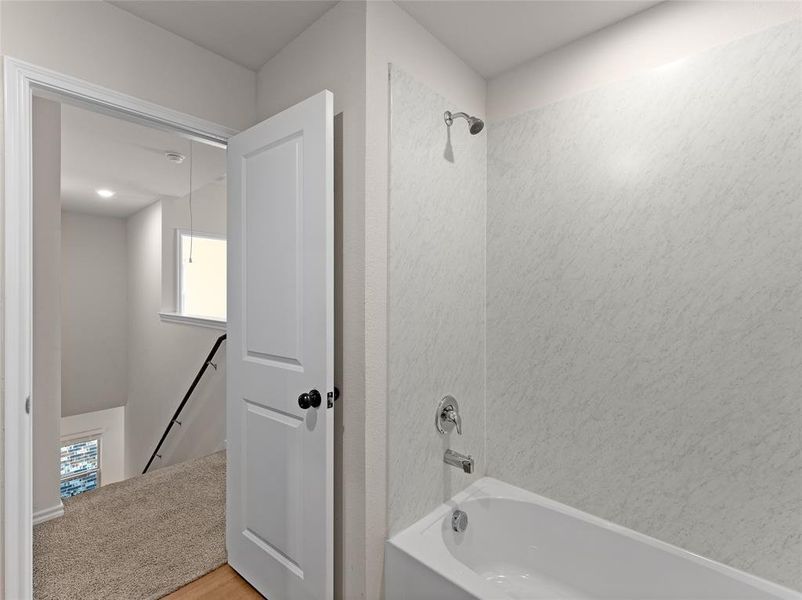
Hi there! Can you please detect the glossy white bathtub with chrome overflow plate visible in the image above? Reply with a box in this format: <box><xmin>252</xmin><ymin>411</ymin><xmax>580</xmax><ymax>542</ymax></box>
<box><xmin>385</xmin><ymin>477</ymin><xmax>802</xmax><ymax>600</ymax></box>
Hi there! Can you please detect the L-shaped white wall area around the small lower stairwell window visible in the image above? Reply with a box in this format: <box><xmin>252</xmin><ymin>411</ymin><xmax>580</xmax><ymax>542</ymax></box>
<box><xmin>61</xmin><ymin>406</ymin><xmax>125</xmax><ymax>486</ymax></box>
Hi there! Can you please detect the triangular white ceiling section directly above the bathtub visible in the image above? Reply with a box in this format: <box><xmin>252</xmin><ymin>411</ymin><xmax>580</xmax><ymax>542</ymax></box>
<box><xmin>398</xmin><ymin>0</ymin><xmax>659</xmax><ymax>79</ymax></box>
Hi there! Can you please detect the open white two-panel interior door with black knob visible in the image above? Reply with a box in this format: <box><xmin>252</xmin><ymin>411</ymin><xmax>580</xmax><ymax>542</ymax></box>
<box><xmin>226</xmin><ymin>91</ymin><xmax>334</xmax><ymax>600</ymax></box>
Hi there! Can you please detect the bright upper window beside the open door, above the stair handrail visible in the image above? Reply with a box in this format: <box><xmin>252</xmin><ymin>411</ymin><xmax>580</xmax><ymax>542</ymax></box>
<box><xmin>176</xmin><ymin>230</ymin><xmax>226</xmax><ymax>321</ymax></box>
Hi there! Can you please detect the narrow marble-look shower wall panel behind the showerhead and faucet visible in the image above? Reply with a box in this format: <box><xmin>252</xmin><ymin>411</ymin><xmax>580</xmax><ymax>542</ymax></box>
<box><xmin>387</xmin><ymin>67</ymin><xmax>487</xmax><ymax>535</ymax></box>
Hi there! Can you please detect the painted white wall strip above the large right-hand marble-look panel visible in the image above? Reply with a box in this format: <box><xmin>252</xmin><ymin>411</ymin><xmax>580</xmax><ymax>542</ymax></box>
<box><xmin>487</xmin><ymin>1</ymin><xmax>802</xmax><ymax>121</ymax></box>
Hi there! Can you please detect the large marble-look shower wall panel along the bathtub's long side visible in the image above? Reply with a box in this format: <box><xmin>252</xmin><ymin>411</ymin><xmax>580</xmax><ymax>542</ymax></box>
<box><xmin>487</xmin><ymin>21</ymin><xmax>802</xmax><ymax>589</ymax></box>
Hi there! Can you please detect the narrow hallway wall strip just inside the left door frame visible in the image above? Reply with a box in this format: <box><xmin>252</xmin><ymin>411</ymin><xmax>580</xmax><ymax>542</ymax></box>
<box><xmin>31</xmin><ymin>98</ymin><xmax>61</xmax><ymax>518</ymax></box>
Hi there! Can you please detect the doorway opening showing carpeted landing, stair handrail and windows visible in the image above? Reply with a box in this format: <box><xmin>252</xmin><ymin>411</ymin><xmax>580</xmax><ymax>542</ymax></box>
<box><xmin>32</xmin><ymin>95</ymin><xmax>227</xmax><ymax>598</ymax></box>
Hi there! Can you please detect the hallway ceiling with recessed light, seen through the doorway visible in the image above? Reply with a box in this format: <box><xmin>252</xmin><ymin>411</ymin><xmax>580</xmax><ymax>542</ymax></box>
<box><xmin>61</xmin><ymin>104</ymin><xmax>226</xmax><ymax>217</ymax></box>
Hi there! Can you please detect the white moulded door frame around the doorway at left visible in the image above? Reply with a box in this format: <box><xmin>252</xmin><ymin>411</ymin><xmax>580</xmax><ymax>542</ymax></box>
<box><xmin>2</xmin><ymin>57</ymin><xmax>237</xmax><ymax>600</ymax></box>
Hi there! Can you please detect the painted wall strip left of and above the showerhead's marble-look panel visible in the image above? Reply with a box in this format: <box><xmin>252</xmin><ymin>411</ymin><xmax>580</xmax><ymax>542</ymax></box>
<box><xmin>364</xmin><ymin>2</ymin><xmax>486</xmax><ymax>598</ymax></box>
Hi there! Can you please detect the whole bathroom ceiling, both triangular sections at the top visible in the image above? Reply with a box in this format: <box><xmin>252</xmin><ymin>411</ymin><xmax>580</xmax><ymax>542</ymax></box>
<box><xmin>109</xmin><ymin>0</ymin><xmax>659</xmax><ymax>78</ymax></box>
